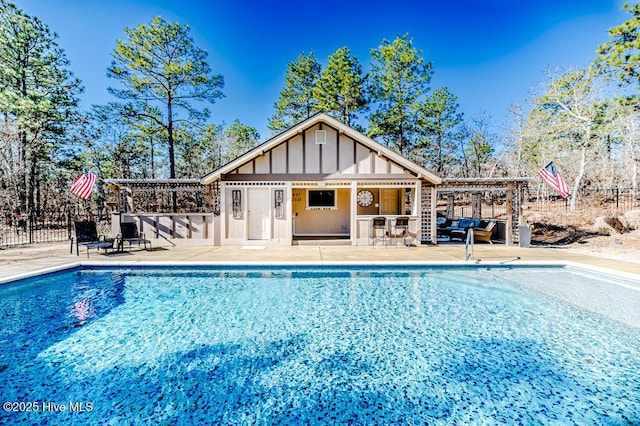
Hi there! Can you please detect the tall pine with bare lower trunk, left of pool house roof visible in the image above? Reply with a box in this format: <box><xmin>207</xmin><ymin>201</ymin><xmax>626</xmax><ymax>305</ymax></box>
<box><xmin>108</xmin><ymin>16</ymin><xmax>224</xmax><ymax>182</ymax></box>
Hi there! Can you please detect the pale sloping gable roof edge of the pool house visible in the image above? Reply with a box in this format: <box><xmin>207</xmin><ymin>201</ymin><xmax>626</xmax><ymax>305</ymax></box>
<box><xmin>200</xmin><ymin>113</ymin><xmax>442</xmax><ymax>185</ymax></box>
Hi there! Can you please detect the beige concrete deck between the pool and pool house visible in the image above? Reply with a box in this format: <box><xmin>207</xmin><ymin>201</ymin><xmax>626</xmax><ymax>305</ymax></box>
<box><xmin>0</xmin><ymin>243</ymin><xmax>640</xmax><ymax>282</ymax></box>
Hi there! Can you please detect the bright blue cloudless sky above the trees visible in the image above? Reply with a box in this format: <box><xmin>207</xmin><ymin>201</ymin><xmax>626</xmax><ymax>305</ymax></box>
<box><xmin>15</xmin><ymin>0</ymin><xmax>630</xmax><ymax>140</ymax></box>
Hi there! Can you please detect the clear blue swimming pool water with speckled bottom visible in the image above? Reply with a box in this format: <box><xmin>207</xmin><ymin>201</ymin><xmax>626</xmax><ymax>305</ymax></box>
<box><xmin>0</xmin><ymin>267</ymin><xmax>640</xmax><ymax>425</ymax></box>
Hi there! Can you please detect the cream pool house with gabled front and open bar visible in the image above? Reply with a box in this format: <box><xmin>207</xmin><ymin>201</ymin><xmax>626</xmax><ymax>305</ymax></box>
<box><xmin>201</xmin><ymin>114</ymin><xmax>441</xmax><ymax>245</ymax></box>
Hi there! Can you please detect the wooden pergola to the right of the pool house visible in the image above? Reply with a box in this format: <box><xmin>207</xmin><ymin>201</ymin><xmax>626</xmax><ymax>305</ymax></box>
<box><xmin>437</xmin><ymin>177</ymin><xmax>532</xmax><ymax>245</ymax></box>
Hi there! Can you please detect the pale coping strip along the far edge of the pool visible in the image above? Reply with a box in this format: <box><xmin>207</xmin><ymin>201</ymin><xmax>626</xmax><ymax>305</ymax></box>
<box><xmin>0</xmin><ymin>259</ymin><xmax>640</xmax><ymax>290</ymax></box>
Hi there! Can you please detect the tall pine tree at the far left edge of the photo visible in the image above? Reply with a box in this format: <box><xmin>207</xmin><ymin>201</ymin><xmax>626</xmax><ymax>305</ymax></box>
<box><xmin>0</xmin><ymin>0</ymin><xmax>82</xmax><ymax>213</ymax></box>
